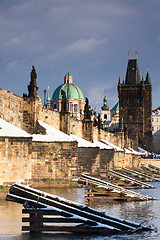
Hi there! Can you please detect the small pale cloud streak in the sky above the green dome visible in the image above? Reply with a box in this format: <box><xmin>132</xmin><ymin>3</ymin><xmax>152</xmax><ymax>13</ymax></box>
<box><xmin>66</xmin><ymin>38</ymin><xmax>108</xmax><ymax>52</ymax></box>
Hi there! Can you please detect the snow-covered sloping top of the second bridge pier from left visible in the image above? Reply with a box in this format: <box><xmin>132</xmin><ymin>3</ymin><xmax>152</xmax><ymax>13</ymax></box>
<box><xmin>32</xmin><ymin>120</ymin><xmax>75</xmax><ymax>142</ymax></box>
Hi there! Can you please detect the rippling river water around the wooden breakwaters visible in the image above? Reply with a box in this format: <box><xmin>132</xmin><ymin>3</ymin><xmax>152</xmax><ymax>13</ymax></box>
<box><xmin>0</xmin><ymin>182</ymin><xmax>160</xmax><ymax>240</ymax></box>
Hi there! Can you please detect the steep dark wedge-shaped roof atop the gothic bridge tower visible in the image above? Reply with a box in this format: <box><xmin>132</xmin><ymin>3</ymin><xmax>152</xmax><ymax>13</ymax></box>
<box><xmin>125</xmin><ymin>59</ymin><xmax>141</xmax><ymax>85</ymax></box>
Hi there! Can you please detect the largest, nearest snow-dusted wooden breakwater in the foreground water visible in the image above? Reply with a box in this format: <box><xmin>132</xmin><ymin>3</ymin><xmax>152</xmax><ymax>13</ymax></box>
<box><xmin>6</xmin><ymin>184</ymin><xmax>152</xmax><ymax>235</ymax></box>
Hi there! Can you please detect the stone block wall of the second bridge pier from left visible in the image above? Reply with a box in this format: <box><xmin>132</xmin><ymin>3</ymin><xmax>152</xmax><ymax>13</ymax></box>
<box><xmin>32</xmin><ymin>142</ymin><xmax>78</xmax><ymax>186</ymax></box>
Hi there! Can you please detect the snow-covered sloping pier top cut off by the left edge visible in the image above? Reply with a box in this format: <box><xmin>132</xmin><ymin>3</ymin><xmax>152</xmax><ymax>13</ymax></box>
<box><xmin>0</xmin><ymin>118</ymin><xmax>31</xmax><ymax>137</ymax></box>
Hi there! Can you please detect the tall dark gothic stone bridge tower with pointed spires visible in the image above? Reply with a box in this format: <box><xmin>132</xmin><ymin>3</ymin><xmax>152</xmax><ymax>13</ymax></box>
<box><xmin>118</xmin><ymin>59</ymin><xmax>152</xmax><ymax>151</ymax></box>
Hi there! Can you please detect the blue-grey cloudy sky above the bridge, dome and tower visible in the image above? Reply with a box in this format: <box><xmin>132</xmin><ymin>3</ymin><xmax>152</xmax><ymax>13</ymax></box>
<box><xmin>0</xmin><ymin>0</ymin><xmax>160</xmax><ymax>112</ymax></box>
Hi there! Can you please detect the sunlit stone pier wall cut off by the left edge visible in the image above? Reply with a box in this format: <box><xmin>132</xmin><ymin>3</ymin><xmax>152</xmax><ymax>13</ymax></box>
<box><xmin>0</xmin><ymin>137</ymin><xmax>32</xmax><ymax>185</ymax></box>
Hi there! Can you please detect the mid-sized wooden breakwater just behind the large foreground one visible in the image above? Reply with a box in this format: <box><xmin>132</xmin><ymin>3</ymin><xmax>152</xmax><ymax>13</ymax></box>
<box><xmin>78</xmin><ymin>174</ymin><xmax>155</xmax><ymax>201</ymax></box>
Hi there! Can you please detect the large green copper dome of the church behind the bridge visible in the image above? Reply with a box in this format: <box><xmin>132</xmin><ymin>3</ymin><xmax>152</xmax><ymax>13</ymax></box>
<box><xmin>52</xmin><ymin>83</ymin><xmax>84</xmax><ymax>100</ymax></box>
